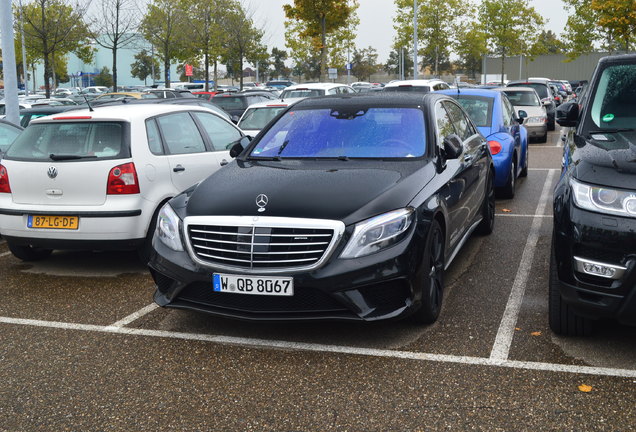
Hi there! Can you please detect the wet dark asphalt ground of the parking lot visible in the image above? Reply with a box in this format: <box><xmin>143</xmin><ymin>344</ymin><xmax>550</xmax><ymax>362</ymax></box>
<box><xmin>0</xmin><ymin>131</ymin><xmax>636</xmax><ymax>431</ymax></box>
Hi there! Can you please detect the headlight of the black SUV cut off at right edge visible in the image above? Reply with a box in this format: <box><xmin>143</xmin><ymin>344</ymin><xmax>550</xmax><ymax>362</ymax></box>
<box><xmin>570</xmin><ymin>179</ymin><xmax>636</xmax><ymax>217</ymax></box>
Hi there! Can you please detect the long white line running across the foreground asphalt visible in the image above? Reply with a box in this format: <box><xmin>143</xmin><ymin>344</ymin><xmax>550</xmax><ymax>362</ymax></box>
<box><xmin>0</xmin><ymin>317</ymin><xmax>636</xmax><ymax>378</ymax></box>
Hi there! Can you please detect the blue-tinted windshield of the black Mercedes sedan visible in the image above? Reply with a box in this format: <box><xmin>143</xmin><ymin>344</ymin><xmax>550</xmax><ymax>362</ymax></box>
<box><xmin>250</xmin><ymin>108</ymin><xmax>426</xmax><ymax>158</ymax></box>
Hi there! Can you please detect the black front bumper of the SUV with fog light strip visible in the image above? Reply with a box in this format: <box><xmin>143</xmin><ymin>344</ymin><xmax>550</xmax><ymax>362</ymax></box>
<box><xmin>554</xmin><ymin>202</ymin><xmax>636</xmax><ymax>325</ymax></box>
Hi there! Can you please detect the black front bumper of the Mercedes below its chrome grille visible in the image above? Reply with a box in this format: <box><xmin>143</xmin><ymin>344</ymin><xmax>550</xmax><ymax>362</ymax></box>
<box><xmin>149</xmin><ymin>229</ymin><xmax>424</xmax><ymax>321</ymax></box>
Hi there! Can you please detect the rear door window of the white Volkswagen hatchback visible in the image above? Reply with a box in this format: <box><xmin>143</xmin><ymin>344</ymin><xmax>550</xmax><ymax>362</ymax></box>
<box><xmin>157</xmin><ymin>112</ymin><xmax>206</xmax><ymax>154</ymax></box>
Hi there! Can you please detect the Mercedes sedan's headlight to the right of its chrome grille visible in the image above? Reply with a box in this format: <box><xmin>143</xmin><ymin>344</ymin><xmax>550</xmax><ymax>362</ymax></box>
<box><xmin>340</xmin><ymin>208</ymin><xmax>415</xmax><ymax>258</ymax></box>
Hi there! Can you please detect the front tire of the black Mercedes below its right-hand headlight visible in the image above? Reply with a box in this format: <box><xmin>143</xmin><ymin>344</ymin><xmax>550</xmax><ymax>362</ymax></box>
<box><xmin>412</xmin><ymin>220</ymin><xmax>444</xmax><ymax>324</ymax></box>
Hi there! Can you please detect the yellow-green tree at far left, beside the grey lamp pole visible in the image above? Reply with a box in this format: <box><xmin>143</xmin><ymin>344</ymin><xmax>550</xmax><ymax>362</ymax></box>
<box><xmin>15</xmin><ymin>0</ymin><xmax>93</xmax><ymax>97</ymax></box>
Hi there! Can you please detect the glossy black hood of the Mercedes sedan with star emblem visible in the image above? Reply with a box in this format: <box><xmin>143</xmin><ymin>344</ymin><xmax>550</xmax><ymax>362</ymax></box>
<box><xmin>182</xmin><ymin>159</ymin><xmax>435</xmax><ymax>225</ymax></box>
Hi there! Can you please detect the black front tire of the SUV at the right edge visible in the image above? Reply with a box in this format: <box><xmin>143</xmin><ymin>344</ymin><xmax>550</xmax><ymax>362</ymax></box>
<box><xmin>548</xmin><ymin>241</ymin><xmax>592</xmax><ymax>336</ymax></box>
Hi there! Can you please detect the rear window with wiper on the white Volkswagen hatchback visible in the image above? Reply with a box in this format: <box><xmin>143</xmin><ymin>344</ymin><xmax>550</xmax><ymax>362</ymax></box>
<box><xmin>5</xmin><ymin>122</ymin><xmax>130</xmax><ymax>161</ymax></box>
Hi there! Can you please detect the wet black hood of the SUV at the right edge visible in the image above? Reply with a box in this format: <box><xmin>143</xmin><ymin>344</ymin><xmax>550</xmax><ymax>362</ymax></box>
<box><xmin>569</xmin><ymin>132</ymin><xmax>636</xmax><ymax>189</ymax></box>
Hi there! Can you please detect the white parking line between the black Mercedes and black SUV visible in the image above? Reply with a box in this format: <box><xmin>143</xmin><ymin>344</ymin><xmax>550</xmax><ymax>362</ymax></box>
<box><xmin>490</xmin><ymin>169</ymin><xmax>558</xmax><ymax>361</ymax></box>
